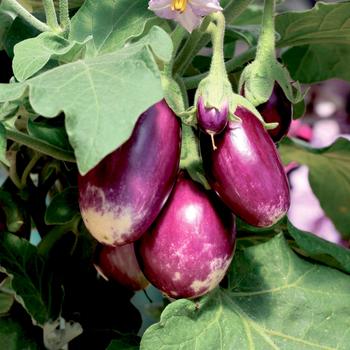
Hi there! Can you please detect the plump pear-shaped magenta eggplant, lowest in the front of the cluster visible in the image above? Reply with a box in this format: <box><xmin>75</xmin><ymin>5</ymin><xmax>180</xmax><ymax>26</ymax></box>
<box><xmin>139</xmin><ymin>173</ymin><xmax>236</xmax><ymax>298</ymax></box>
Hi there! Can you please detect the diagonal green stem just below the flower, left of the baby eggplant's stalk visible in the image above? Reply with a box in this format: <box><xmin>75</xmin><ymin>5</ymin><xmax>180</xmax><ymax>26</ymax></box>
<box><xmin>174</xmin><ymin>18</ymin><xmax>210</xmax><ymax>75</ymax></box>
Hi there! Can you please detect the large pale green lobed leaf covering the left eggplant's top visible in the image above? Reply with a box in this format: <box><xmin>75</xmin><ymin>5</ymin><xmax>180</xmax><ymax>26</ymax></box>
<box><xmin>0</xmin><ymin>27</ymin><xmax>172</xmax><ymax>174</ymax></box>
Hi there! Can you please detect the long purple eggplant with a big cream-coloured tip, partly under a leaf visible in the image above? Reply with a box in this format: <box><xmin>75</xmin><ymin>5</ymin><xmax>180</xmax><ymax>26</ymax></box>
<box><xmin>78</xmin><ymin>100</ymin><xmax>181</xmax><ymax>245</ymax></box>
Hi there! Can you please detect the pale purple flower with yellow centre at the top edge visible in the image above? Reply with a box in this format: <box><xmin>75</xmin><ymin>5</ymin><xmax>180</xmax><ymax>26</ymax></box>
<box><xmin>148</xmin><ymin>0</ymin><xmax>222</xmax><ymax>33</ymax></box>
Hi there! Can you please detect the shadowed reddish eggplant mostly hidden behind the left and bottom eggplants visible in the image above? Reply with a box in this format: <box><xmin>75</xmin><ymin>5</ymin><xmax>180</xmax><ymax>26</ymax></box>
<box><xmin>95</xmin><ymin>243</ymin><xmax>149</xmax><ymax>291</ymax></box>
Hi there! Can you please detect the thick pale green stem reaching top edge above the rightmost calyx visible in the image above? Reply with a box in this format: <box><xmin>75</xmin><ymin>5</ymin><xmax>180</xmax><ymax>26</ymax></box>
<box><xmin>256</xmin><ymin>0</ymin><xmax>276</xmax><ymax>61</ymax></box>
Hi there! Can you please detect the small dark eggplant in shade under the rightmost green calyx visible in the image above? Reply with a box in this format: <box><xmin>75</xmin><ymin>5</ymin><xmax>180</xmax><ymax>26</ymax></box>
<box><xmin>257</xmin><ymin>83</ymin><xmax>293</xmax><ymax>142</ymax></box>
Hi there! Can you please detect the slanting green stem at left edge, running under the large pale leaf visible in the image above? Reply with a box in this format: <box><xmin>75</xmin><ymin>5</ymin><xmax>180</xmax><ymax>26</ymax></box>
<box><xmin>6</xmin><ymin>128</ymin><xmax>76</xmax><ymax>163</ymax></box>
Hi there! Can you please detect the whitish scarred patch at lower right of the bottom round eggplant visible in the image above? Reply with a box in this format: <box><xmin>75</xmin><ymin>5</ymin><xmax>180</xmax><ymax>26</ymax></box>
<box><xmin>191</xmin><ymin>256</ymin><xmax>232</xmax><ymax>296</ymax></box>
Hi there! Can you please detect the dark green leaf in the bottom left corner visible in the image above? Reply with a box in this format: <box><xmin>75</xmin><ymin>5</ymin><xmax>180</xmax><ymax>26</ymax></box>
<box><xmin>0</xmin><ymin>317</ymin><xmax>41</xmax><ymax>350</ymax></box>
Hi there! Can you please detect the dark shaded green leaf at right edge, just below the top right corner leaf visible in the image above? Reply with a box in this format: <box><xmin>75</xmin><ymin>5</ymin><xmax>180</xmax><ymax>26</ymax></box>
<box><xmin>282</xmin><ymin>44</ymin><xmax>350</xmax><ymax>84</ymax></box>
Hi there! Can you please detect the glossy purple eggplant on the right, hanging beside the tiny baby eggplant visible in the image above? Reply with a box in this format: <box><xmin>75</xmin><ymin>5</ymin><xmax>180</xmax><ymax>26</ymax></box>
<box><xmin>201</xmin><ymin>106</ymin><xmax>290</xmax><ymax>227</ymax></box>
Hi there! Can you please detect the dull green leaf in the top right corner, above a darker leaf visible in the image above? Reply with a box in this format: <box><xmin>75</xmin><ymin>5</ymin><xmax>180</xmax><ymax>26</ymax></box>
<box><xmin>276</xmin><ymin>1</ymin><xmax>350</xmax><ymax>47</ymax></box>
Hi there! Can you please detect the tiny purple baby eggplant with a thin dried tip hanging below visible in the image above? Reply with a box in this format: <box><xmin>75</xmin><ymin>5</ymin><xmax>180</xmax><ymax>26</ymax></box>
<box><xmin>197</xmin><ymin>96</ymin><xmax>228</xmax><ymax>149</ymax></box>
